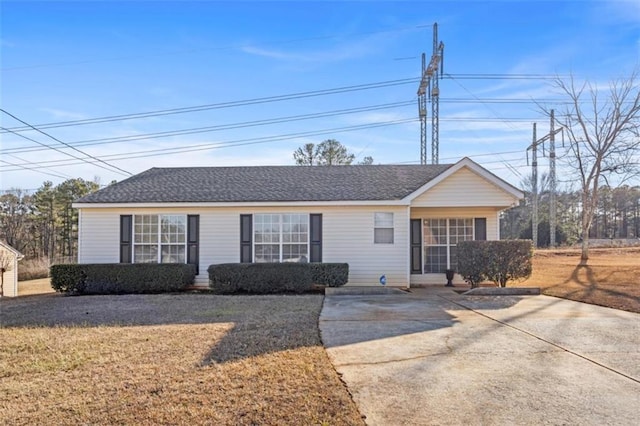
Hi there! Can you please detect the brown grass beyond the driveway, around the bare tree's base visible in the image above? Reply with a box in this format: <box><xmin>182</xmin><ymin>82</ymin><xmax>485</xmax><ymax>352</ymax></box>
<box><xmin>515</xmin><ymin>247</ymin><xmax>640</xmax><ymax>312</ymax></box>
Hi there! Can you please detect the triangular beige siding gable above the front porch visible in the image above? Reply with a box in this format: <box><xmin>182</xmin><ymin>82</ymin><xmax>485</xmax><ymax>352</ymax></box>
<box><xmin>411</xmin><ymin>168</ymin><xmax>517</xmax><ymax>208</ymax></box>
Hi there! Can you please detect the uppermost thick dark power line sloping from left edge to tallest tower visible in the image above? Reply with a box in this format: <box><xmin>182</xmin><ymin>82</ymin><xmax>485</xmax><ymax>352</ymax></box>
<box><xmin>1</xmin><ymin>78</ymin><xmax>418</xmax><ymax>132</ymax></box>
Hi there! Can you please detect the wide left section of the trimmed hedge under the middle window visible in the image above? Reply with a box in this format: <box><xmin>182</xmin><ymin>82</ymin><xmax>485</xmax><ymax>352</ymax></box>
<box><xmin>207</xmin><ymin>263</ymin><xmax>312</xmax><ymax>294</ymax></box>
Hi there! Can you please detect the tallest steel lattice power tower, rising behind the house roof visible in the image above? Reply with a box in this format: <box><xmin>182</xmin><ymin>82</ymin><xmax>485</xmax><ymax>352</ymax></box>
<box><xmin>418</xmin><ymin>22</ymin><xmax>444</xmax><ymax>164</ymax></box>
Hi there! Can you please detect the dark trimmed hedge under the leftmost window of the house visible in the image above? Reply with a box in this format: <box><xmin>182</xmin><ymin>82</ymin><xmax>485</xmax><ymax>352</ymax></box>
<box><xmin>51</xmin><ymin>263</ymin><xmax>195</xmax><ymax>294</ymax></box>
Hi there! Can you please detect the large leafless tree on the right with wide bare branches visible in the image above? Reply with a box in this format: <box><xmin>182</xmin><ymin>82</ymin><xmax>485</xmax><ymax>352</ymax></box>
<box><xmin>545</xmin><ymin>70</ymin><xmax>640</xmax><ymax>263</ymax></box>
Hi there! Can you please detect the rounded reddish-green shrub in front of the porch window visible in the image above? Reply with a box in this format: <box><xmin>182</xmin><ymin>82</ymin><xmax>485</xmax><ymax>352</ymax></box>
<box><xmin>458</xmin><ymin>240</ymin><xmax>533</xmax><ymax>287</ymax></box>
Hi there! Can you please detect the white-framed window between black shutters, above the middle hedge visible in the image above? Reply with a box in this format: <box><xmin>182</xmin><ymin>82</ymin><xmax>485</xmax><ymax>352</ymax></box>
<box><xmin>253</xmin><ymin>214</ymin><xmax>309</xmax><ymax>262</ymax></box>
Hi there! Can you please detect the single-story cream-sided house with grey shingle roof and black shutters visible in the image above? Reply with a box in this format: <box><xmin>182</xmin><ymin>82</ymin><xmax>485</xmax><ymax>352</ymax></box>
<box><xmin>73</xmin><ymin>158</ymin><xmax>523</xmax><ymax>287</ymax></box>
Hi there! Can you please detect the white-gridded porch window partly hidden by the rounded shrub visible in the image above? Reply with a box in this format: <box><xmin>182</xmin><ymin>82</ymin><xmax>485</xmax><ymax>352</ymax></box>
<box><xmin>424</xmin><ymin>219</ymin><xmax>473</xmax><ymax>274</ymax></box>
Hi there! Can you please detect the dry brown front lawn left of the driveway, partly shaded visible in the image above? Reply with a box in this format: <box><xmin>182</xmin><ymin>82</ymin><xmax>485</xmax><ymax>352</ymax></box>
<box><xmin>0</xmin><ymin>294</ymin><xmax>363</xmax><ymax>425</ymax></box>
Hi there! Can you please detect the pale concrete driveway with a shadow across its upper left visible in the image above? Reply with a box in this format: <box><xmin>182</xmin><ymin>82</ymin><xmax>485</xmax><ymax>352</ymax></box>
<box><xmin>320</xmin><ymin>288</ymin><xmax>640</xmax><ymax>425</ymax></box>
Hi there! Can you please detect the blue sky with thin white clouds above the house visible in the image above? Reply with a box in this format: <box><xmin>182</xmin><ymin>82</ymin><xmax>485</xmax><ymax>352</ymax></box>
<box><xmin>0</xmin><ymin>0</ymin><xmax>640</xmax><ymax>190</ymax></box>
